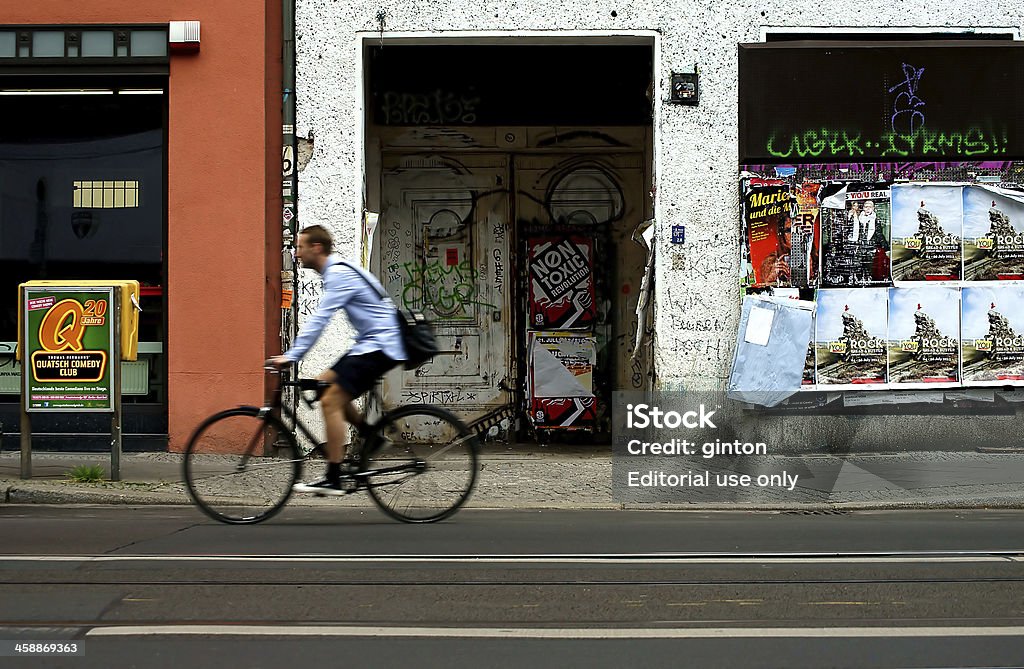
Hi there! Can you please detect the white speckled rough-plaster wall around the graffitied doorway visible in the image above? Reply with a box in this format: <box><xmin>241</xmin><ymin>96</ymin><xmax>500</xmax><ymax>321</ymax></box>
<box><xmin>297</xmin><ymin>0</ymin><xmax>1021</xmax><ymax>388</ymax></box>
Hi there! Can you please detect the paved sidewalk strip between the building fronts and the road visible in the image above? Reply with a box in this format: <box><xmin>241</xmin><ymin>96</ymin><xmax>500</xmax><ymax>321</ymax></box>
<box><xmin>0</xmin><ymin>445</ymin><xmax>1024</xmax><ymax>510</ymax></box>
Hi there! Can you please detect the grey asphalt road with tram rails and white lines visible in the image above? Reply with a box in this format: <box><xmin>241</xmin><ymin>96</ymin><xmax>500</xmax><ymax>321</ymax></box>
<box><xmin>0</xmin><ymin>505</ymin><xmax>1024</xmax><ymax>668</ymax></box>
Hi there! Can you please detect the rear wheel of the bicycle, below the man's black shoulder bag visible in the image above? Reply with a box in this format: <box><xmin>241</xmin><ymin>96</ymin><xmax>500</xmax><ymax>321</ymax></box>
<box><xmin>362</xmin><ymin>405</ymin><xmax>477</xmax><ymax>522</ymax></box>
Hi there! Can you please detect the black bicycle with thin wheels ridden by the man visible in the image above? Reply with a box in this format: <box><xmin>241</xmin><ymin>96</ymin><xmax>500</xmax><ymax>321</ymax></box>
<box><xmin>184</xmin><ymin>370</ymin><xmax>478</xmax><ymax>525</ymax></box>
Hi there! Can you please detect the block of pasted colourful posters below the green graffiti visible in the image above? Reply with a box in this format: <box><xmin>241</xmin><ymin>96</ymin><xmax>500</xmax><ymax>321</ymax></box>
<box><xmin>743</xmin><ymin>178</ymin><xmax>1024</xmax><ymax>390</ymax></box>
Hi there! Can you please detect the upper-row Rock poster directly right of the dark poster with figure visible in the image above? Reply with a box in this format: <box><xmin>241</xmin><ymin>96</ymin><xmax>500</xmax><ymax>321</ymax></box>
<box><xmin>892</xmin><ymin>183</ymin><xmax>964</xmax><ymax>282</ymax></box>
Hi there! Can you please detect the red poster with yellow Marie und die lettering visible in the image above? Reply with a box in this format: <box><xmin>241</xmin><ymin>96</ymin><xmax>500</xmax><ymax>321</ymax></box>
<box><xmin>743</xmin><ymin>185</ymin><xmax>794</xmax><ymax>287</ymax></box>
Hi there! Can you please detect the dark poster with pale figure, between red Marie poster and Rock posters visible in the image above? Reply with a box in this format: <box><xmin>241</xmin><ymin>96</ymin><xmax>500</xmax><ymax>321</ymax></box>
<box><xmin>820</xmin><ymin>183</ymin><xmax>892</xmax><ymax>288</ymax></box>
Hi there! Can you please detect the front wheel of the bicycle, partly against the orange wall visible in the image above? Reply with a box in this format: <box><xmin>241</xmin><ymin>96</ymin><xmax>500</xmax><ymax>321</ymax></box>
<box><xmin>184</xmin><ymin>407</ymin><xmax>303</xmax><ymax>525</ymax></box>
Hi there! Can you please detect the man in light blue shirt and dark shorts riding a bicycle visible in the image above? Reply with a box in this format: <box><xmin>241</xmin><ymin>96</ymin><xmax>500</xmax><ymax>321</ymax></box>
<box><xmin>266</xmin><ymin>225</ymin><xmax>406</xmax><ymax>495</ymax></box>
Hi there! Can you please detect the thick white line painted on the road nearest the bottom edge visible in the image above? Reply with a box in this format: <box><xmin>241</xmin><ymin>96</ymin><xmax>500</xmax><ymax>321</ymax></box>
<box><xmin>85</xmin><ymin>624</ymin><xmax>1024</xmax><ymax>639</ymax></box>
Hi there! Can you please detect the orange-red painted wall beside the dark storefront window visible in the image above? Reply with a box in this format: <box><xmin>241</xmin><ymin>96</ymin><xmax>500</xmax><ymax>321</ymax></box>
<box><xmin>7</xmin><ymin>0</ymin><xmax>281</xmax><ymax>451</ymax></box>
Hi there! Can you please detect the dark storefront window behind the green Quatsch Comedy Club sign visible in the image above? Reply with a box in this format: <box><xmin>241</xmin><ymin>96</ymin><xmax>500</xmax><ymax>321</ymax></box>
<box><xmin>0</xmin><ymin>89</ymin><xmax>166</xmax><ymax>402</ymax></box>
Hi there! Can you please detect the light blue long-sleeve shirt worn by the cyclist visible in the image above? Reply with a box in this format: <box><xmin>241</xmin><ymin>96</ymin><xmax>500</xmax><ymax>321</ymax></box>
<box><xmin>285</xmin><ymin>253</ymin><xmax>406</xmax><ymax>363</ymax></box>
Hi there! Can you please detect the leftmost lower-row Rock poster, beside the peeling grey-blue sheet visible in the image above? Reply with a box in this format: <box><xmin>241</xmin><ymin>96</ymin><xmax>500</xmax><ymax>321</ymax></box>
<box><xmin>814</xmin><ymin>288</ymin><xmax>889</xmax><ymax>388</ymax></box>
